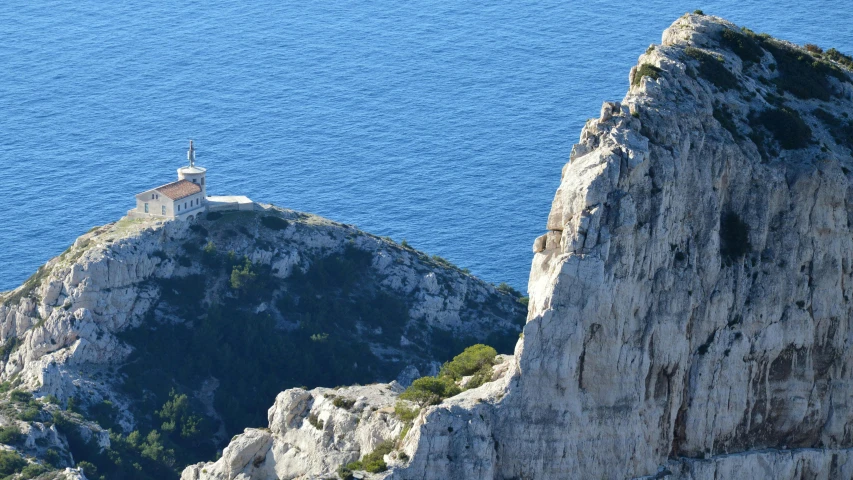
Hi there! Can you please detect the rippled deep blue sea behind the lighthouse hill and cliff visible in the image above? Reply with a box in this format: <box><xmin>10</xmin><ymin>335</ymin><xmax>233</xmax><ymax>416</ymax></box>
<box><xmin>0</xmin><ymin>0</ymin><xmax>853</xmax><ymax>290</ymax></box>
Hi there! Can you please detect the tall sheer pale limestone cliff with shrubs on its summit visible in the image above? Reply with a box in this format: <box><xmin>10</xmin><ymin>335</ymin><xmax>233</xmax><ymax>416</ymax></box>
<box><xmin>185</xmin><ymin>15</ymin><xmax>853</xmax><ymax>480</ymax></box>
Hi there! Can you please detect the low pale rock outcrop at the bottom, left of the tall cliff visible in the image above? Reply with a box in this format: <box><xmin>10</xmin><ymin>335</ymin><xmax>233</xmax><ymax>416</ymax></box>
<box><xmin>181</xmin><ymin>383</ymin><xmax>405</xmax><ymax>480</ymax></box>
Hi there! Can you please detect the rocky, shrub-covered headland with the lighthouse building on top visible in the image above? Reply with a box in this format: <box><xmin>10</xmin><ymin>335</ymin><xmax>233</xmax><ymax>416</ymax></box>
<box><xmin>0</xmin><ymin>205</ymin><xmax>526</xmax><ymax>478</ymax></box>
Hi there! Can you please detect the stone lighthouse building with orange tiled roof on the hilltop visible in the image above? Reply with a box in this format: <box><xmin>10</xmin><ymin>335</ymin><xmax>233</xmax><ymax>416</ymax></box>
<box><xmin>127</xmin><ymin>140</ymin><xmax>255</xmax><ymax>220</ymax></box>
